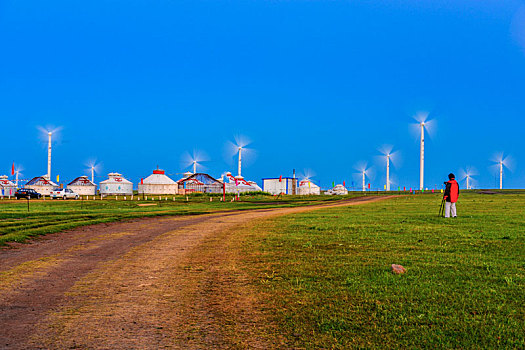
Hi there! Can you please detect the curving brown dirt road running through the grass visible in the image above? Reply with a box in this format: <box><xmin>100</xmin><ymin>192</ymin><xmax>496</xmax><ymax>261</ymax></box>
<box><xmin>0</xmin><ymin>197</ymin><xmax>383</xmax><ymax>349</ymax></box>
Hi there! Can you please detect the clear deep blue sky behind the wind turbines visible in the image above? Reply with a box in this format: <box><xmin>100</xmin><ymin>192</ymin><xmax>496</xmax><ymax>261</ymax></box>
<box><xmin>0</xmin><ymin>0</ymin><xmax>525</xmax><ymax>188</ymax></box>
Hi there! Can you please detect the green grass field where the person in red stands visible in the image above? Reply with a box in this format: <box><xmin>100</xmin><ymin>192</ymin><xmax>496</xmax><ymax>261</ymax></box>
<box><xmin>241</xmin><ymin>193</ymin><xmax>525</xmax><ymax>349</ymax></box>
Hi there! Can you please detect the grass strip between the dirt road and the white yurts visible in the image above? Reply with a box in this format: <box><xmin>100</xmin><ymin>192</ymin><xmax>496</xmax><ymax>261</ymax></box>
<box><xmin>0</xmin><ymin>193</ymin><xmax>361</xmax><ymax>246</ymax></box>
